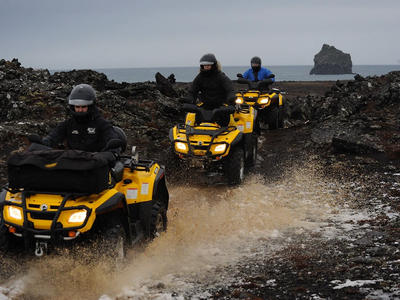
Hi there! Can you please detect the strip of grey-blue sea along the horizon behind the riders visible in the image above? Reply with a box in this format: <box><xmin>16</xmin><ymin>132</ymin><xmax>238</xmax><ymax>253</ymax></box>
<box><xmin>49</xmin><ymin>64</ymin><xmax>400</xmax><ymax>83</ymax></box>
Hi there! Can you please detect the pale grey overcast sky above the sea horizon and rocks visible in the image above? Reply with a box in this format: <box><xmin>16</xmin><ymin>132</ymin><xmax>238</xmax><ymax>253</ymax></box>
<box><xmin>0</xmin><ymin>0</ymin><xmax>400</xmax><ymax>70</ymax></box>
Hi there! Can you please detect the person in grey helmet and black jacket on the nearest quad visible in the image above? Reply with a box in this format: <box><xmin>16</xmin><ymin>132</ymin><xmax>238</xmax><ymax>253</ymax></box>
<box><xmin>42</xmin><ymin>84</ymin><xmax>119</xmax><ymax>158</ymax></box>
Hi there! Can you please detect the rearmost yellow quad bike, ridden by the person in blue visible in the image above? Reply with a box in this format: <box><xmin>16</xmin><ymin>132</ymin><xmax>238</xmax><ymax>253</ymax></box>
<box><xmin>236</xmin><ymin>74</ymin><xmax>285</xmax><ymax>130</ymax></box>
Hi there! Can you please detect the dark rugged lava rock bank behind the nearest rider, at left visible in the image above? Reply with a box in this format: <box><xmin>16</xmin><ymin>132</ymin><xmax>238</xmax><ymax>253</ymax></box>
<box><xmin>0</xmin><ymin>59</ymin><xmax>187</xmax><ymax>175</ymax></box>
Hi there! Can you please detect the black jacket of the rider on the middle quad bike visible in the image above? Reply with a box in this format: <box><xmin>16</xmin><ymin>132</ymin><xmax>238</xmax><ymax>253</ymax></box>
<box><xmin>187</xmin><ymin>69</ymin><xmax>236</xmax><ymax>109</ymax></box>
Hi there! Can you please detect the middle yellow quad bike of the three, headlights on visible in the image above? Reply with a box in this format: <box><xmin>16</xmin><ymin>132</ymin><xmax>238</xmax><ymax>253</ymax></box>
<box><xmin>166</xmin><ymin>104</ymin><xmax>258</xmax><ymax>185</ymax></box>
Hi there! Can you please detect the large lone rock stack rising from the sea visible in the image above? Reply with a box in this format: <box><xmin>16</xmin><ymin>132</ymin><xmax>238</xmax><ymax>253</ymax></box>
<box><xmin>310</xmin><ymin>44</ymin><xmax>353</xmax><ymax>75</ymax></box>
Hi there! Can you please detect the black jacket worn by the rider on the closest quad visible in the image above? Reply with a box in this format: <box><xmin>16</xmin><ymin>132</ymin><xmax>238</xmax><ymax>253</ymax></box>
<box><xmin>43</xmin><ymin>107</ymin><xmax>118</xmax><ymax>152</ymax></box>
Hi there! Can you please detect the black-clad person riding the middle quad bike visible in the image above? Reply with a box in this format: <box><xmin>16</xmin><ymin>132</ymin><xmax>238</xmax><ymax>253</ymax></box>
<box><xmin>187</xmin><ymin>53</ymin><xmax>236</xmax><ymax>123</ymax></box>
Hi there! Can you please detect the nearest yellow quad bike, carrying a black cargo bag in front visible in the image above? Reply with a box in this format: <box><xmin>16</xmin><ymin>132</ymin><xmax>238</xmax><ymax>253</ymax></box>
<box><xmin>0</xmin><ymin>128</ymin><xmax>169</xmax><ymax>263</ymax></box>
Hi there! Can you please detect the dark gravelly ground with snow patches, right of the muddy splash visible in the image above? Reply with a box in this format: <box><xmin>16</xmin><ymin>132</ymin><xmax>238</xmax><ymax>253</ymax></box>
<box><xmin>215</xmin><ymin>120</ymin><xmax>400</xmax><ymax>299</ymax></box>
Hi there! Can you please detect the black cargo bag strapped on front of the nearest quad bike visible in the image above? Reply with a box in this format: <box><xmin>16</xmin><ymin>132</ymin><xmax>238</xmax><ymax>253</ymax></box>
<box><xmin>7</xmin><ymin>150</ymin><xmax>110</xmax><ymax>194</ymax></box>
